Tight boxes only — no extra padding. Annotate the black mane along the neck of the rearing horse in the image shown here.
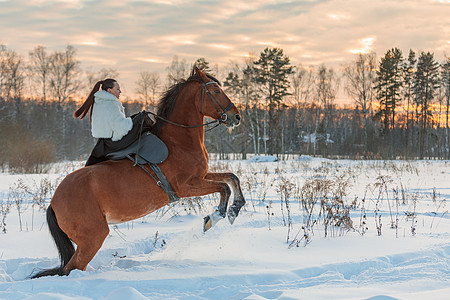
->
[152,66,221,135]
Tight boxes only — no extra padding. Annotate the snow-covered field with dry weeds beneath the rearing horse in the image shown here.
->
[0,156,450,300]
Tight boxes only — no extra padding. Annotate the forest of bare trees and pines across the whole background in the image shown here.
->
[0,44,450,172]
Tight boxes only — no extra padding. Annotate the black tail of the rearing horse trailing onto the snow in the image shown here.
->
[31,205,75,278]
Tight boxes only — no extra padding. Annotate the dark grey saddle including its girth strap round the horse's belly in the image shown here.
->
[106,131,180,203]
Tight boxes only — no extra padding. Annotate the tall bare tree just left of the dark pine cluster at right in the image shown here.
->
[343,53,376,153]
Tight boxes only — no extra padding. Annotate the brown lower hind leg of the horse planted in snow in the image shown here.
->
[60,220,109,274]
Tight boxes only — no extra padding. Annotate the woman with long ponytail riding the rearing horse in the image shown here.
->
[73,78,145,166]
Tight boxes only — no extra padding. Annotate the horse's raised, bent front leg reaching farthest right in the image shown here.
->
[205,173,245,224]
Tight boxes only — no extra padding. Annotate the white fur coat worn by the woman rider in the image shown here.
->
[91,90,133,141]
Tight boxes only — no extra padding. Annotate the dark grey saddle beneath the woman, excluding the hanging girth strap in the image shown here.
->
[106,132,169,164]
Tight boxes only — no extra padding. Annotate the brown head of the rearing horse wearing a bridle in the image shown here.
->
[195,67,241,128]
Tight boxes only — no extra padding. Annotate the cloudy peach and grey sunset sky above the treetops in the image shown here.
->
[0,0,450,101]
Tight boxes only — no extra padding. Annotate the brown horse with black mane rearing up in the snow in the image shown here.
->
[32,68,245,278]
